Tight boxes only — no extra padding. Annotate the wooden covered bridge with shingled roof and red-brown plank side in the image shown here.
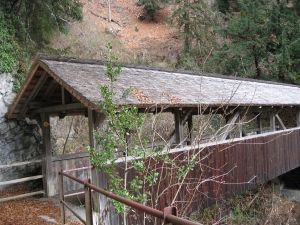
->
[7,56,300,214]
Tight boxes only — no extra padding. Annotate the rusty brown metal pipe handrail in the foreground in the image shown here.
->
[59,170,201,225]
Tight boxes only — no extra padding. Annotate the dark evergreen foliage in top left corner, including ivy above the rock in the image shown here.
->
[0,0,82,71]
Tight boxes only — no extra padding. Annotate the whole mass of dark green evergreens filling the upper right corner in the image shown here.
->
[206,0,300,84]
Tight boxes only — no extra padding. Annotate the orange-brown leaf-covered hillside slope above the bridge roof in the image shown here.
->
[52,0,182,67]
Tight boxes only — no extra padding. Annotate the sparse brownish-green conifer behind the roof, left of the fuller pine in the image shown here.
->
[168,0,216,69]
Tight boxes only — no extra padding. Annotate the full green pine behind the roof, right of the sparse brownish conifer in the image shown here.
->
[209,0,269,78]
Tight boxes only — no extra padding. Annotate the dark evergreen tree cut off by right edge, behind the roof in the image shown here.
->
[268,1,300,84]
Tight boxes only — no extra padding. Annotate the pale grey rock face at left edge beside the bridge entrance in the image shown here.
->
[0,73,42,189]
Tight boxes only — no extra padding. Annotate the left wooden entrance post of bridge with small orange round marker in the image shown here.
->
[41,113,55,197]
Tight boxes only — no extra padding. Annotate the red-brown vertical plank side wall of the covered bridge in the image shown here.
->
[111,129,300,224]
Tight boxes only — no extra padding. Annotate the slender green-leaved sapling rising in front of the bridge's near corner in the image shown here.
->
[89,44,145,223]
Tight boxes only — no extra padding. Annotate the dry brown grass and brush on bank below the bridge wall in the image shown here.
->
[194,183,300,225]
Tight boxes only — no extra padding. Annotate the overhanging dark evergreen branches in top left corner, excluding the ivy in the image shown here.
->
[0,0,82,50]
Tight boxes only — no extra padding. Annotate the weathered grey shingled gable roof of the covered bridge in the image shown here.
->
[7,56,300,119]
